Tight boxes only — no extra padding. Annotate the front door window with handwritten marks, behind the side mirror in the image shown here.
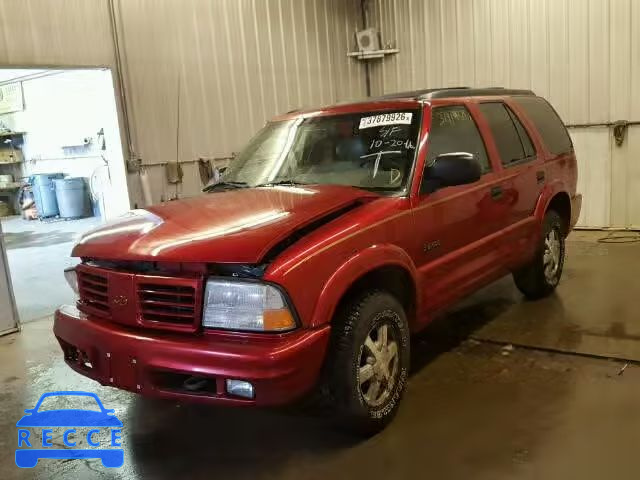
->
[421,105,491,192]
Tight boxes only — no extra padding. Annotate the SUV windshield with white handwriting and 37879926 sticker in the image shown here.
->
[222,110,420,191]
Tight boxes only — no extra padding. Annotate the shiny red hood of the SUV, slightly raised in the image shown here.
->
[72,185,379,263]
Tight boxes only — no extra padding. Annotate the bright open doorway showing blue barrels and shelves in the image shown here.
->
[0,68,129,323]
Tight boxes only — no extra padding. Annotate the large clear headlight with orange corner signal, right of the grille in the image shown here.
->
[202,279,296,332]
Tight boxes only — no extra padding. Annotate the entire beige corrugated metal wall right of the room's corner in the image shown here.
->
[368,0,640,227]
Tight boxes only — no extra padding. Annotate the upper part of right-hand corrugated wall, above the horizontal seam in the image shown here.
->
[370,0,640,124]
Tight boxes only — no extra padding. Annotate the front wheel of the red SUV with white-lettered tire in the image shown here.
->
[327,291,410,435]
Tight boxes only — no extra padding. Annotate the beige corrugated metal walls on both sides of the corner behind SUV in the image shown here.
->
[0,0,640,227]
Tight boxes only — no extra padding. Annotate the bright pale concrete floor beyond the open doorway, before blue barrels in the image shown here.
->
[2,217,100,323]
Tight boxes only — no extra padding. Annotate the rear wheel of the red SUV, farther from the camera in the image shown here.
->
[513,210,566,300]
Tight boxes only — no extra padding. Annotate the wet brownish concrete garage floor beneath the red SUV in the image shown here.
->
[0,233,640,480]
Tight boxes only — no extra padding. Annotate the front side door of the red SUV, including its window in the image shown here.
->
[413,104,508,311]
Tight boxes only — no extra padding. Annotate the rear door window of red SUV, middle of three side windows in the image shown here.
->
[480,102,535,167]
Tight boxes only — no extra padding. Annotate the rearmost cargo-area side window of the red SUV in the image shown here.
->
[513,97,573,155]
